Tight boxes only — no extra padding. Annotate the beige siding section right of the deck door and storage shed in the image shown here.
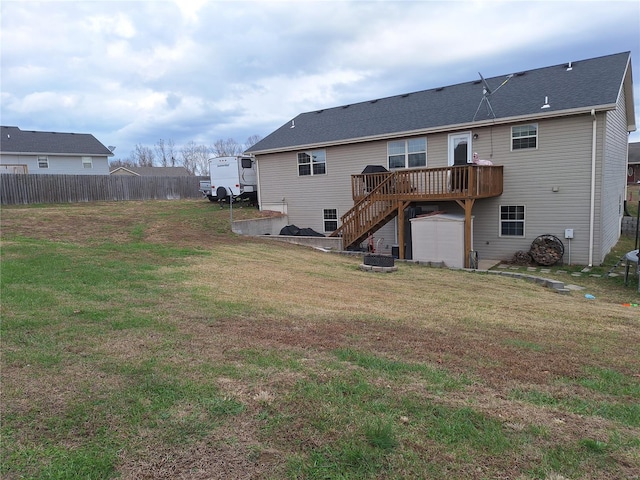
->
[473,115,591,264]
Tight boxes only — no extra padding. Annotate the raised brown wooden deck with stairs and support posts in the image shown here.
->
[331,165,503,261]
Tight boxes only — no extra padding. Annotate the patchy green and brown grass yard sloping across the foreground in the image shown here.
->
[0,201,640,480]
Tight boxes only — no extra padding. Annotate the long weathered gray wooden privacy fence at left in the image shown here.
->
[0,174,206,205]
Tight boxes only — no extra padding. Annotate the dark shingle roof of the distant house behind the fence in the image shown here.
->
[0,126,113,157]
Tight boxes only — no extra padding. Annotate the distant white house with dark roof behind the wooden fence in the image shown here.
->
[0,126,113,175]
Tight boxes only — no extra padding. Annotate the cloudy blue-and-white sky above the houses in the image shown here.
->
[0,0,640,159]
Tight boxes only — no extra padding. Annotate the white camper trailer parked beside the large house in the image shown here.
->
[200,156,258,203]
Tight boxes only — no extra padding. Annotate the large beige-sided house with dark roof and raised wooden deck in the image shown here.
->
[247,52,636,265]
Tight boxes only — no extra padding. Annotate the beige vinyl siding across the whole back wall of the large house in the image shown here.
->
[258,112,625,265]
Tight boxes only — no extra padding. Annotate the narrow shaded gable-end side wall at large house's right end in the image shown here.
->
[594,89,628,263]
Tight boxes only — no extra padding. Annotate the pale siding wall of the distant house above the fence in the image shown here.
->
[0,154,109,175]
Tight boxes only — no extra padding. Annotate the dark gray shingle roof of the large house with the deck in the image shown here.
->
[247,52,635,153]
